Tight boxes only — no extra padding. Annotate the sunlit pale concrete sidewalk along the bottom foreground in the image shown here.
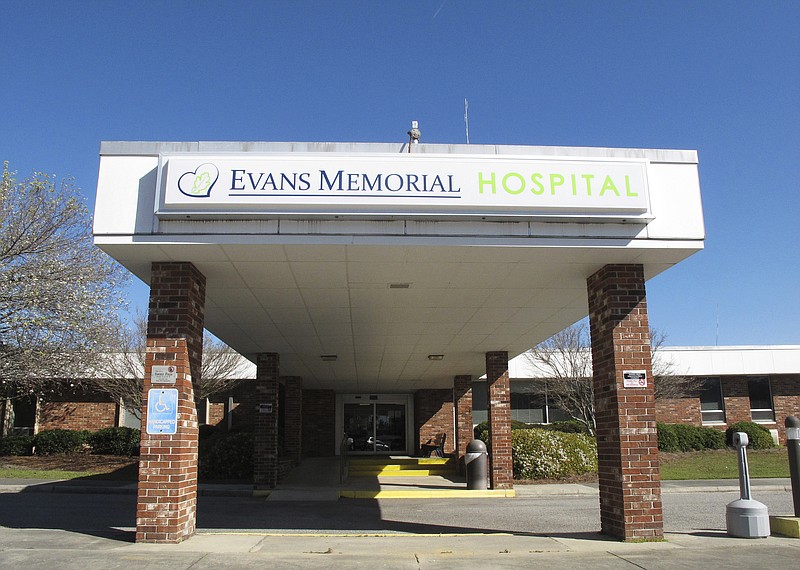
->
[0,528,800,570]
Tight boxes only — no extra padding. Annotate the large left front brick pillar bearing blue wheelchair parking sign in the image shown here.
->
[136,263,205,543]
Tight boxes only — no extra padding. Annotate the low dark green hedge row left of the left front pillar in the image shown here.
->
[0,427,139,456]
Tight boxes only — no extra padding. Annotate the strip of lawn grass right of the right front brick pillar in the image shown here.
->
[661,448,789,480]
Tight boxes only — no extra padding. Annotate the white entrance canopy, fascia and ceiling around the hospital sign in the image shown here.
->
[95,143,703,392]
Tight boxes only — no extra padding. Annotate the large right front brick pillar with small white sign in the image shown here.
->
[587,264,664,540]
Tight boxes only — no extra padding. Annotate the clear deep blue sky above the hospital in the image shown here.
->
[0,0,800,345]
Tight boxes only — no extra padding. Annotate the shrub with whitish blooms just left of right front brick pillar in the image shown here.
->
[511,429,597,479]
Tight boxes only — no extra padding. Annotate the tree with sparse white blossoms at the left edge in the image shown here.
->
[0,162,127,397]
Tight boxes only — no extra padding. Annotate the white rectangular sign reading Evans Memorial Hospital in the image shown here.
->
[157,154,652,220]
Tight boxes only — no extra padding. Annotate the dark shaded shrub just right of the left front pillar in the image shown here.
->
[198,432,253,480]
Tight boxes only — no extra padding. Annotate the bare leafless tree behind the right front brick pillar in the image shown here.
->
[525,320,691,433]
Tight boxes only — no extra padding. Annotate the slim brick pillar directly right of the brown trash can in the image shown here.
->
[486,351,514,489]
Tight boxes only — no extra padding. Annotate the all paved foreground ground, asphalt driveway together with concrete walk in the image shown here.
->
[0,480,800,570]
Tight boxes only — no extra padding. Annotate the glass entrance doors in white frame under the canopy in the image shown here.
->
[337,394,411,455]
